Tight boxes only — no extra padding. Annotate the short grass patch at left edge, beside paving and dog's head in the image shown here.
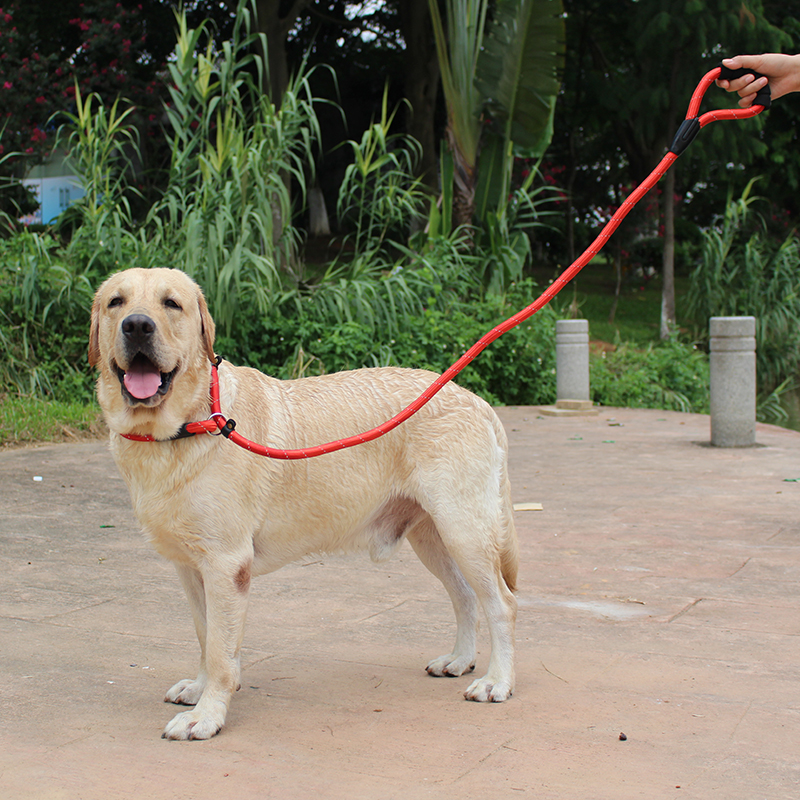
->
[0,396,105,447]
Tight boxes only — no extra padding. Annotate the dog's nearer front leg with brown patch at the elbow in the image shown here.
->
[163,554,252,739]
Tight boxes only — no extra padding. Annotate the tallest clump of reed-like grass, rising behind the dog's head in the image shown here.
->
[146,0,320,333]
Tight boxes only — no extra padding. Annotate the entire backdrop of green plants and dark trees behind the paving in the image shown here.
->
[0,0,800,439]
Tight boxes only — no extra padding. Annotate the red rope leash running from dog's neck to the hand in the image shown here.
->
[126,67,769,459]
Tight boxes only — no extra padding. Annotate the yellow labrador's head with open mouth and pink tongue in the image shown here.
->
[89,269,214,439]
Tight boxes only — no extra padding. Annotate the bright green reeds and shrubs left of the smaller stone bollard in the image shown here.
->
[0,4,568,416]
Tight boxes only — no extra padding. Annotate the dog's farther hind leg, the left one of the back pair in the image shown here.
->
[407,516,478,678]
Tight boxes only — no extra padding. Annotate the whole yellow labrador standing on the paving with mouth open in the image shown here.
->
[89,269,518,739]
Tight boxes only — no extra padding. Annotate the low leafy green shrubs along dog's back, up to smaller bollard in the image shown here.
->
[217,281,555,405]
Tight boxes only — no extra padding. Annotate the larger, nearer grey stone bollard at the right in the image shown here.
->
[709,317,756,447]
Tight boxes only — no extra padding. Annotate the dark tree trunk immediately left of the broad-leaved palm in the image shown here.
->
[399,0,439,192]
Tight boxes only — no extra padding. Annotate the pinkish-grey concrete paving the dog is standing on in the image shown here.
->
[0,408,800,800]
